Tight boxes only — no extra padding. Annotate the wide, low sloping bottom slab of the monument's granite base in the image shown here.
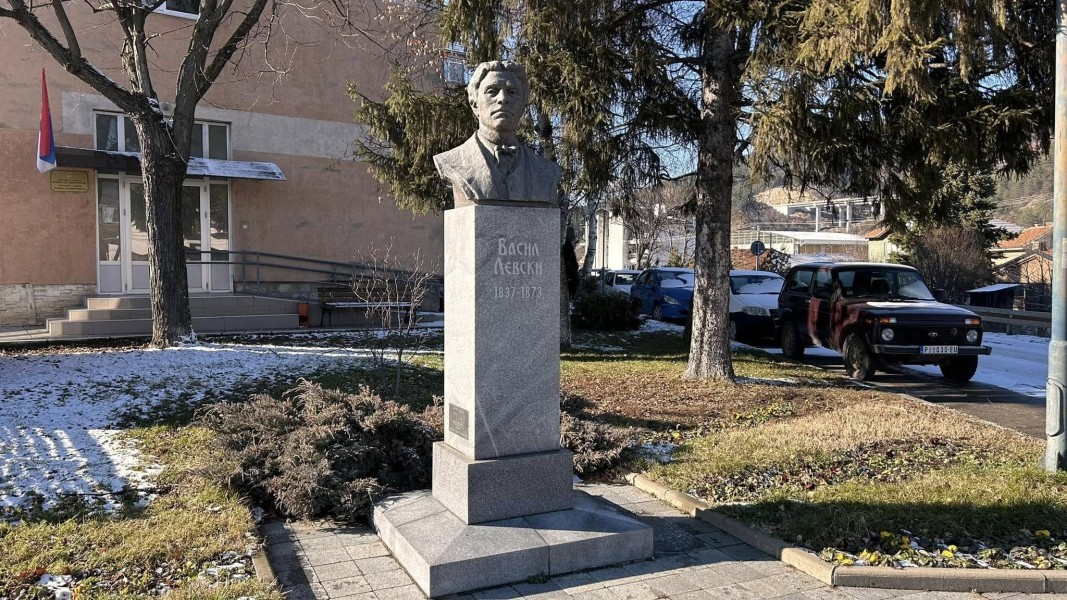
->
[373,490,652,598]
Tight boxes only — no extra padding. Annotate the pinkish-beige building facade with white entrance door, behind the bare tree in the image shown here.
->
[0,3,443,326]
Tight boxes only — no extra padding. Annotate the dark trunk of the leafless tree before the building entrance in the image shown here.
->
[130,112,195,348]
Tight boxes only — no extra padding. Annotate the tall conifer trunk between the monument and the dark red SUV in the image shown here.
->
[685,23,739,380]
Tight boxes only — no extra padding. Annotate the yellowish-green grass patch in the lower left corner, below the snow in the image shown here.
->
[0,427,281,600]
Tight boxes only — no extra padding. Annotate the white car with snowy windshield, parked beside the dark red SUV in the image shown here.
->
[730,270,785,340]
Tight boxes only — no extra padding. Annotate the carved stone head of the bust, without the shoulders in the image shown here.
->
[467,61,529,143]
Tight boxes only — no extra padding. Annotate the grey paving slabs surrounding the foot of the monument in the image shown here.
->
[264,485,1067,600]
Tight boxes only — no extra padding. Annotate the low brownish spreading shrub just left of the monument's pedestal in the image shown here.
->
[203,380,436,520]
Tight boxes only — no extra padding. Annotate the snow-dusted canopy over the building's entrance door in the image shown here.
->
[55,146,285,181]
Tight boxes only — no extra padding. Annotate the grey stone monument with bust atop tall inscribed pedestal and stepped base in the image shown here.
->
[373,61,652,597]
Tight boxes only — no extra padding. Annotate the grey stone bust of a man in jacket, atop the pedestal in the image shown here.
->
[433,61,562,207]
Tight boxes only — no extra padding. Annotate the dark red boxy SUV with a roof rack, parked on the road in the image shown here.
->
[777,263,989,382]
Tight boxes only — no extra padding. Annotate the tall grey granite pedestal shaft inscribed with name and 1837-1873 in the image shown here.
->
[445,205,560,460]
